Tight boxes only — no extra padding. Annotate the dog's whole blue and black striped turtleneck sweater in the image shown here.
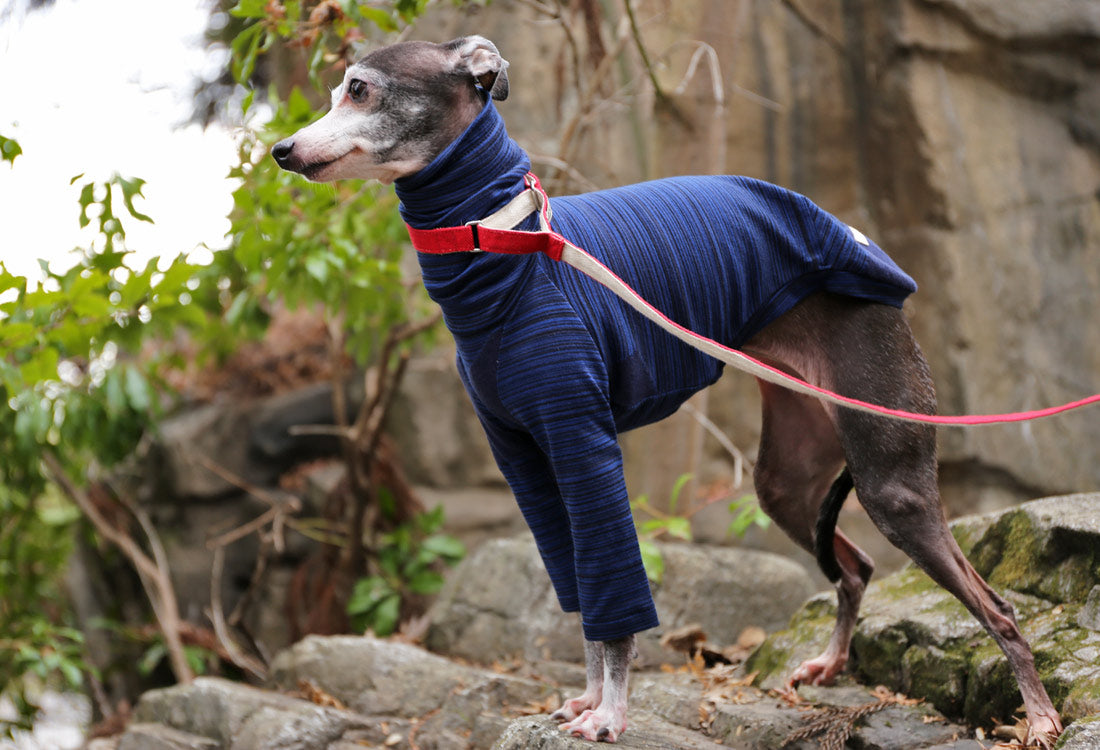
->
[396,97,915,640]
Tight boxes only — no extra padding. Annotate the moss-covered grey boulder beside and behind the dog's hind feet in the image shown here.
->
[749,494,1100,724]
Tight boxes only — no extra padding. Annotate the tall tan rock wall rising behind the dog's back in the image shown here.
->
[400,0,1100,571]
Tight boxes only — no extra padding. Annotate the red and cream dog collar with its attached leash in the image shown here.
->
[408,173,1100,427]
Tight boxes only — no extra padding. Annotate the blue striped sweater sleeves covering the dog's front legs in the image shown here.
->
[483,271,658,640]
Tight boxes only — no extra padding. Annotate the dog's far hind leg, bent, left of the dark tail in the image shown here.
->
[755,383,875,685]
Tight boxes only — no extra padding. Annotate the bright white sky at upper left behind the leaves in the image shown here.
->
[0,0,235,276]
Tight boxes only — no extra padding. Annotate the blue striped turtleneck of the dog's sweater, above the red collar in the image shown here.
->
[394,99,530,229]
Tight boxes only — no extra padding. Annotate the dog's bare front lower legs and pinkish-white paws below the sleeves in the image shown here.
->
[551,636,638,742]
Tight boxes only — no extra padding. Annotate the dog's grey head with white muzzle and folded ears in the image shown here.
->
[272,36,508,183]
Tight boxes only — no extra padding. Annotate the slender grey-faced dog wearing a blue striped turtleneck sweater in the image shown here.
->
[272,36,1062,746]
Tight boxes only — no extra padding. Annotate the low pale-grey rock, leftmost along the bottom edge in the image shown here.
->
[122,677,369,750]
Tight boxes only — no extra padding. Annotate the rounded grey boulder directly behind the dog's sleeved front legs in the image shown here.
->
[426,534,813,665]
